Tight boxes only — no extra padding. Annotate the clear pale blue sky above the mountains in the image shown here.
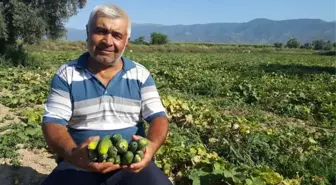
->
[65,0,336,29]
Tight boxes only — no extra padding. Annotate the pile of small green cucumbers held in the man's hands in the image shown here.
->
[88,133,148,165]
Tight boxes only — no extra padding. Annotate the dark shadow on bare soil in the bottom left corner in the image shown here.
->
[0,165,47,185]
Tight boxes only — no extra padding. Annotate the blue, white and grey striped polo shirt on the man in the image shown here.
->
[42,52,166,145]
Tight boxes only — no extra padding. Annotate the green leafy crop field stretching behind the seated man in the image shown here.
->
[0,43,336,185]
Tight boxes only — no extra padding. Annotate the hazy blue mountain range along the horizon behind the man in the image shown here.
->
[67,18,336,44]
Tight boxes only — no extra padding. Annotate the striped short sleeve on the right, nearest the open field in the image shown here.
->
[141,74,167,123]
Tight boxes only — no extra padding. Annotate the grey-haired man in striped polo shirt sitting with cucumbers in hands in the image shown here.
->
[42,5,171,185]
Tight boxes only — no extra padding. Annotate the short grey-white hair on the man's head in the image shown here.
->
[87,4,132,38]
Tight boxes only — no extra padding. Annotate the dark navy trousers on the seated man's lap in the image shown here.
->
[42,161,172,185]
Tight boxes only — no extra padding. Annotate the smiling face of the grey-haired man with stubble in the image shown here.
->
[87,17,128,65]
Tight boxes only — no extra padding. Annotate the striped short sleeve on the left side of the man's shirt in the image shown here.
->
[42,66,72,125]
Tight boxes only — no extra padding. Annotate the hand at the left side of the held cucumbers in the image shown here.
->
[66,136,120,173]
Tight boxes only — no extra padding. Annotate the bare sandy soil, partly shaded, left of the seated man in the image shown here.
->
[0,104,56,185]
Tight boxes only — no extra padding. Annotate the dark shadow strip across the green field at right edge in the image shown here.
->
[259,64,336,75]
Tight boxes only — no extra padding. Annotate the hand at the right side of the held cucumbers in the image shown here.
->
[122,135,157,173]
